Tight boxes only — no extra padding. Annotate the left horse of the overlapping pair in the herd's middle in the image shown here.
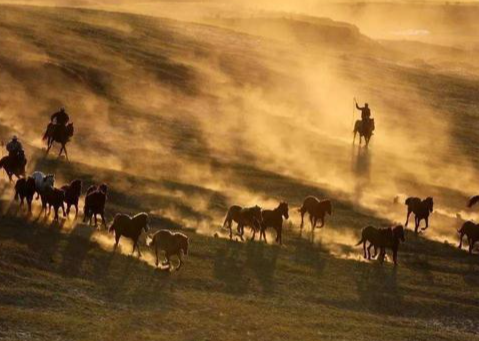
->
[223,205,263,240]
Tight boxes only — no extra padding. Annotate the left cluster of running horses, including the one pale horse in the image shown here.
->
[14,171,189,269]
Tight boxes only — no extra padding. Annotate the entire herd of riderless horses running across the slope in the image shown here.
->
[0,115,479,270]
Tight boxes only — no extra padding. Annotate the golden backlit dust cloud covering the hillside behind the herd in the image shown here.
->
[0,1,479,257]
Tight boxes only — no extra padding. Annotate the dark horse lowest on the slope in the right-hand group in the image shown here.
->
[356,225,405,265]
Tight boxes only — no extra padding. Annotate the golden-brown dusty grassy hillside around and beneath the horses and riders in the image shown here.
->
[0,6,479,340]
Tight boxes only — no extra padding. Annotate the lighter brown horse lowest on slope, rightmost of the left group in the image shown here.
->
[146,230,189,270]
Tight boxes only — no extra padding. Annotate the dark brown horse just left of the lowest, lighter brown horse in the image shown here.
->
[108,213,149,257]
